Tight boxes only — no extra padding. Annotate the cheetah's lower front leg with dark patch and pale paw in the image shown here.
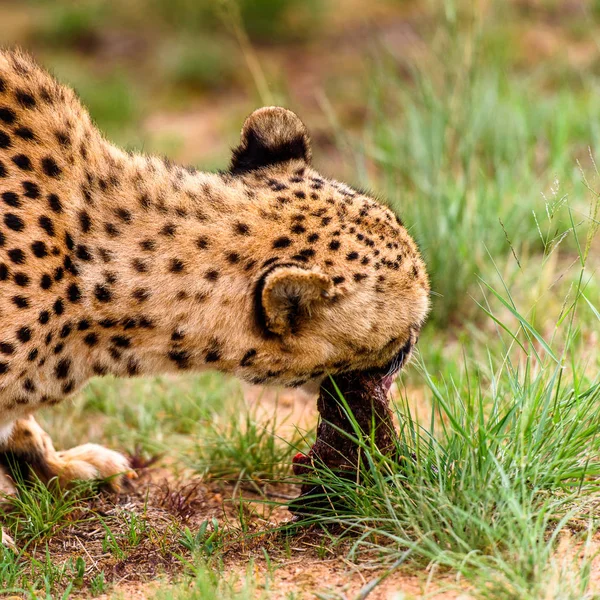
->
[0,415,135,491]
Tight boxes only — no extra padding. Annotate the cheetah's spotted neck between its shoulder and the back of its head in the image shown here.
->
[72,146,253,375]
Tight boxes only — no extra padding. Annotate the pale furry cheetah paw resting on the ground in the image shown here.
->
[57,444,137,491]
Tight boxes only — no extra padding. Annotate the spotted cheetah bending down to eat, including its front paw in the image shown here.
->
[0,51,429,540]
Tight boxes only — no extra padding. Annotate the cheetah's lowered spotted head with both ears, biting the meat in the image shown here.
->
[230,107,429,386]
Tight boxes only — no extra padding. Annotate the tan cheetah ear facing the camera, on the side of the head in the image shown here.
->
[257,266,333,335]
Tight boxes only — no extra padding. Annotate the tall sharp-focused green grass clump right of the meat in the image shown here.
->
[284,182,600,600]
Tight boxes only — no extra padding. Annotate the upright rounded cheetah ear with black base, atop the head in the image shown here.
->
[230,106,311,174]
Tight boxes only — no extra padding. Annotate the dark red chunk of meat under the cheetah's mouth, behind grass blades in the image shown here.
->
[289,371,397,514]
